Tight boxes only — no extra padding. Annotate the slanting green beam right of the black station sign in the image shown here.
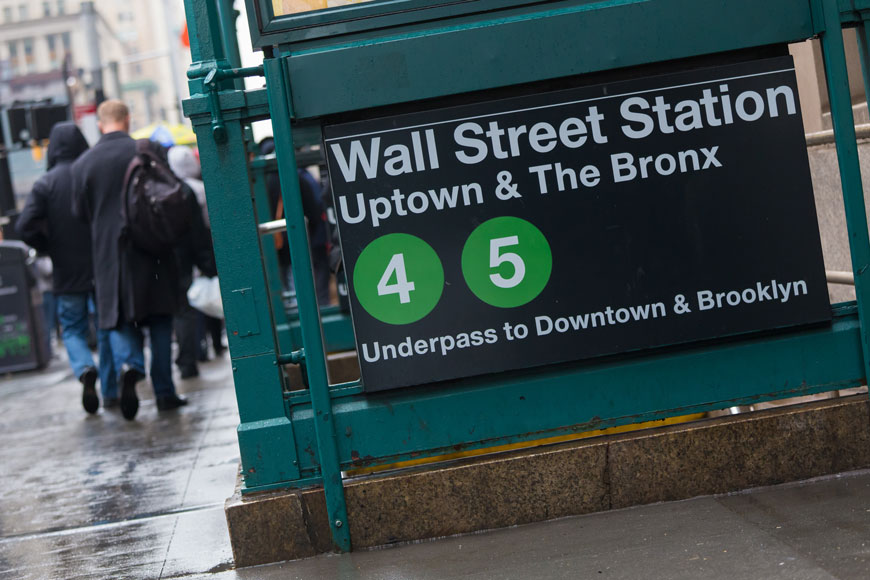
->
[821,0,870,386]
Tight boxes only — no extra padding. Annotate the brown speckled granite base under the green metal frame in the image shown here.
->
[225,394,870,567]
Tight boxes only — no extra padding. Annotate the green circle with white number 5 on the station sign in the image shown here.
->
[462,217,553,308]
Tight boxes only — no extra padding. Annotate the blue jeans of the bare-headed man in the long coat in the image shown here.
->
[109,315,175,397]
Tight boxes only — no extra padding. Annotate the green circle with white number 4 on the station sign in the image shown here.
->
[353,234,444,324]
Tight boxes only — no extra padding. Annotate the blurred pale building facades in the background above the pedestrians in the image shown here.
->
[0,0,190,128]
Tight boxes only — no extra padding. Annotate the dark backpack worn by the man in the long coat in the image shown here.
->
[121,139,192,255]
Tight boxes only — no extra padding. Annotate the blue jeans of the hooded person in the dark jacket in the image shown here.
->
[55,292,118,399]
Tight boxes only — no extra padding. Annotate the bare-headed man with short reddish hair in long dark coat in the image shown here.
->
[72,100,187,419]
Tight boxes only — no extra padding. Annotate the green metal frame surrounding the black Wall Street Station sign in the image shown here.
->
[185,0,870,550]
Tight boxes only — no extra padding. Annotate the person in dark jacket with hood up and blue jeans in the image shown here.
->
[15,122,118,413]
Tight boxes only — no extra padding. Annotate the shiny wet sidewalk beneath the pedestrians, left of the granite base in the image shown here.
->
[0,359,239,580]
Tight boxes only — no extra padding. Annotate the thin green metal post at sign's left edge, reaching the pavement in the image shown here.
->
[264,59,351,552]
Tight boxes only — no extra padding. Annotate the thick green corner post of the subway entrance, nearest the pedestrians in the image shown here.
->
[185,0,299,487]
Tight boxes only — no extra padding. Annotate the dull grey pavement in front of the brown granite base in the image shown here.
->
[203,472,870,580]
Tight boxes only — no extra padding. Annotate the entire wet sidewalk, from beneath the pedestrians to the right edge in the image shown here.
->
[0,358,870,580]
